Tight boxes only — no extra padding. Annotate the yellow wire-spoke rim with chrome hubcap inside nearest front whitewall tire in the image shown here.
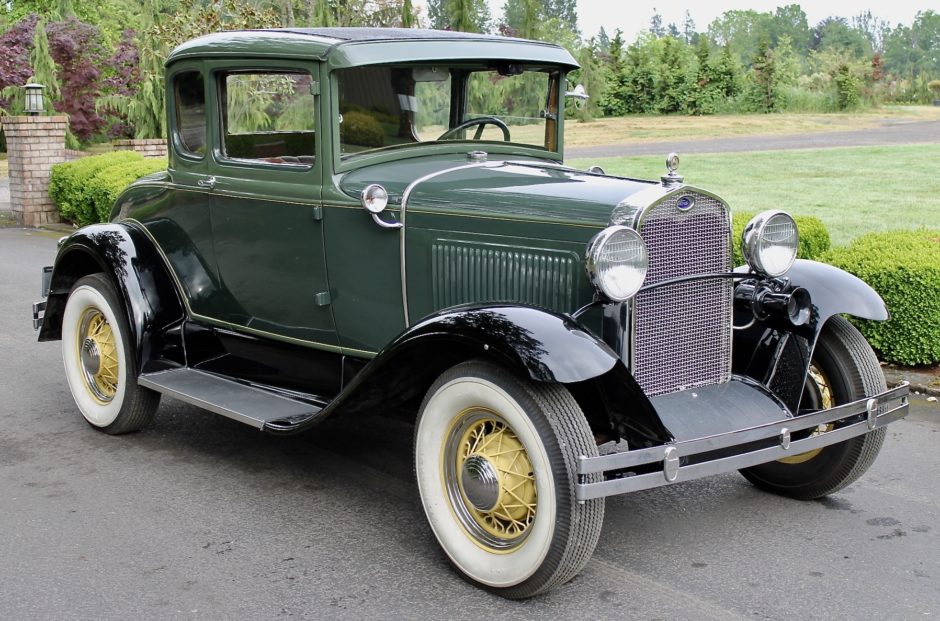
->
[442,408,538,551]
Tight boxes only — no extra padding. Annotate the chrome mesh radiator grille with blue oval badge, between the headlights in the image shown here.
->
[633,194,734,395]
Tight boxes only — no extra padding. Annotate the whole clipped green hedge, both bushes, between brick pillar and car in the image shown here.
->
[49,151,166,226]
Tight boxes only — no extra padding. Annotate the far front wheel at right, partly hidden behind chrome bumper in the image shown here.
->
[741,316,886,500]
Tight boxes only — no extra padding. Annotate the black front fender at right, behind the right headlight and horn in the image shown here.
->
[733,259,888,412]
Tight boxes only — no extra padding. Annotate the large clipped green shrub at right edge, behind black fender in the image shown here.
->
[825,229,940,365]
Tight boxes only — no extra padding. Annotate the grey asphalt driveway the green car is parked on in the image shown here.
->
[0,229,940,621]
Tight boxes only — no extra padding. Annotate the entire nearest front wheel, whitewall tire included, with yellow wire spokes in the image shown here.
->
[415,362,604,598]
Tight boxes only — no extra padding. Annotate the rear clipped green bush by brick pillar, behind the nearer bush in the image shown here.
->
[49,151,144,226]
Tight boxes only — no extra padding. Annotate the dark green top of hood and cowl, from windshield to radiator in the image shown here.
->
[340,156,658,226]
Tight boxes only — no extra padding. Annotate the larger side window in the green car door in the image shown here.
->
[220,72,316,166]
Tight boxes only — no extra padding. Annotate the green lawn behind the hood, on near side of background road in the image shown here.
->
[566,145,940,245]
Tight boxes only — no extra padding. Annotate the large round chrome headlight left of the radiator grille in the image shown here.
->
[586,226,649,302]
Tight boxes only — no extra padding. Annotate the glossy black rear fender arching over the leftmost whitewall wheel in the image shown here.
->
[39,224,185,373]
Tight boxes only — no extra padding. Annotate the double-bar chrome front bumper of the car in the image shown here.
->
[575,382,908,501]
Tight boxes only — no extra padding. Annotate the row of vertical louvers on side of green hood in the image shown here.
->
[431,240,580,312]
